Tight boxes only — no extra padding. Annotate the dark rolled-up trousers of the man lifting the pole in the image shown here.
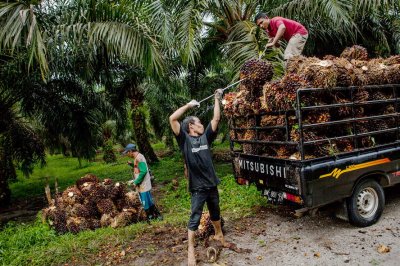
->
[188,187,220,231]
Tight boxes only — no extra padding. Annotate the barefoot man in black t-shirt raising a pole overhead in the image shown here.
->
[169,89,225,266]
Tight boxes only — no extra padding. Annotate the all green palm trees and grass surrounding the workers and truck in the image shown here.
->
[0,0,400,265]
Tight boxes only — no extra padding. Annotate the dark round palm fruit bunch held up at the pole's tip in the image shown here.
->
[240,59,274,91]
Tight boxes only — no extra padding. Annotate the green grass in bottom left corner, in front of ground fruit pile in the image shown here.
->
[0,214,144,266]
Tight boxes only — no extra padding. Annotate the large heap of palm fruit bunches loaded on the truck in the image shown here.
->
[224,45,400,159]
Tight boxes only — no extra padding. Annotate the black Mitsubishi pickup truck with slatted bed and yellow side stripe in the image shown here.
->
[229,84,400,227]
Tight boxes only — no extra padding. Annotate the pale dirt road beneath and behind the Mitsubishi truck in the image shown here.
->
[218,186,400,265]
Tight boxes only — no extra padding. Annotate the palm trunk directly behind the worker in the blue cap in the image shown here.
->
[131,99,158,163]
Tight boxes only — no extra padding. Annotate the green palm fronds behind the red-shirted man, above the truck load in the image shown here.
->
[172,0,400,74]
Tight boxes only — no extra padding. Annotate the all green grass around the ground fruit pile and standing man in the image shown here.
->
[0,144,266,265]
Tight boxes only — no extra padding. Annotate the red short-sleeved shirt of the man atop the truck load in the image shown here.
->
[267,17,308,41]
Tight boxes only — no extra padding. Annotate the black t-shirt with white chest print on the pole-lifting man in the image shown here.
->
[175,123,220,191]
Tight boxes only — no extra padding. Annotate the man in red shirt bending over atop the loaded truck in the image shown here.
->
[254,13,308,62]
